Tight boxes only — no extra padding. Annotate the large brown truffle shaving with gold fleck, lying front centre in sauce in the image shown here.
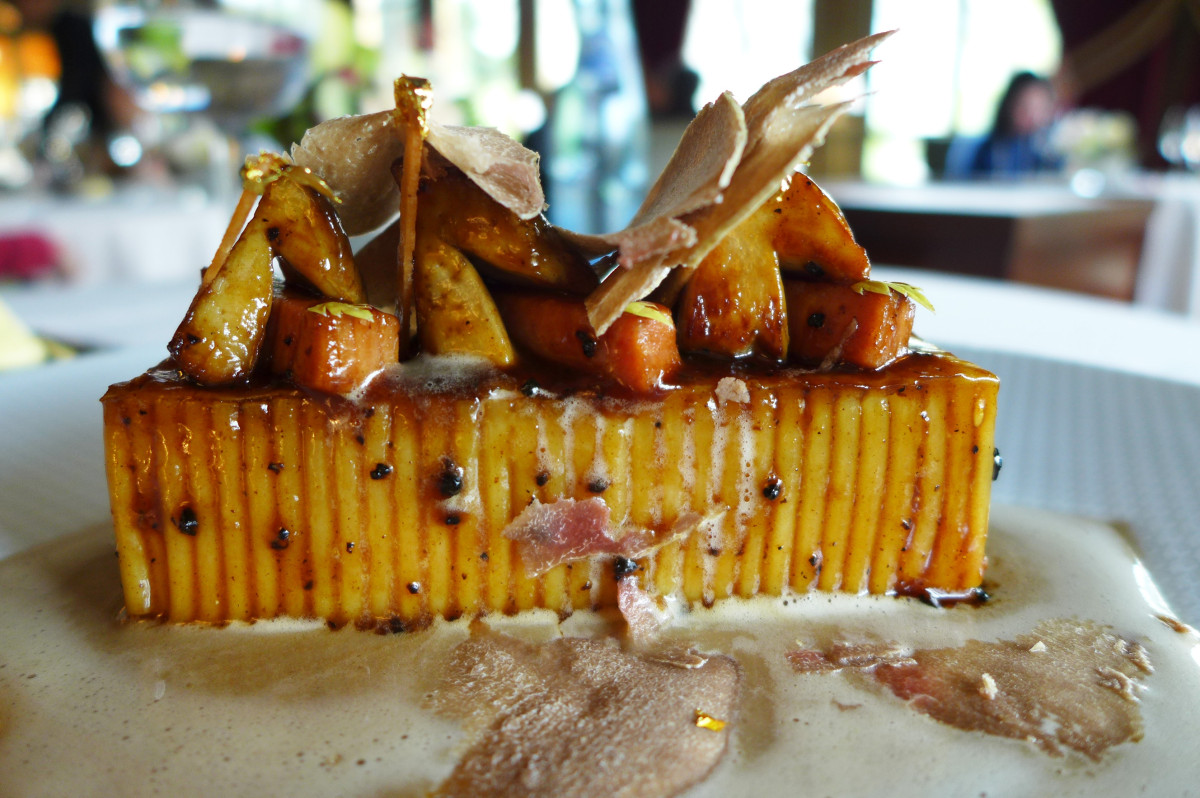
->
[431,632,740,798]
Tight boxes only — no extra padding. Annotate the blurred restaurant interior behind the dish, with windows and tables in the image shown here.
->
[0,0,1200,367]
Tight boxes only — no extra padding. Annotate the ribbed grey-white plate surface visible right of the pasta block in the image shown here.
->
[954,347,1200,625]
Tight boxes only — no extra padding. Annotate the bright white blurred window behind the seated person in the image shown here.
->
[863,0,1062,182]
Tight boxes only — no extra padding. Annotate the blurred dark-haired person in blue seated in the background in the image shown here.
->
[946,72,1062,179]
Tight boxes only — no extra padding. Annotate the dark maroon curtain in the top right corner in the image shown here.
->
[1052,0,1200,168]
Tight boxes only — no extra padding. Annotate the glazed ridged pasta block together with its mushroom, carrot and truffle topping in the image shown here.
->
[102,34,997,630]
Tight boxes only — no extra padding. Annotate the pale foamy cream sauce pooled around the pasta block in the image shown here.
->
[0,508,1200,797]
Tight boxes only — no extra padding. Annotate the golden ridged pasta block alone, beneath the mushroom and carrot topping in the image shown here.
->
[103,353,998,628]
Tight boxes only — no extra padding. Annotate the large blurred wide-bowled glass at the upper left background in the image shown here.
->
[95,0,319,192]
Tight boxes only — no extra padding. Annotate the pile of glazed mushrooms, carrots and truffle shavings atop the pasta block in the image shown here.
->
[170,30,913,394]
